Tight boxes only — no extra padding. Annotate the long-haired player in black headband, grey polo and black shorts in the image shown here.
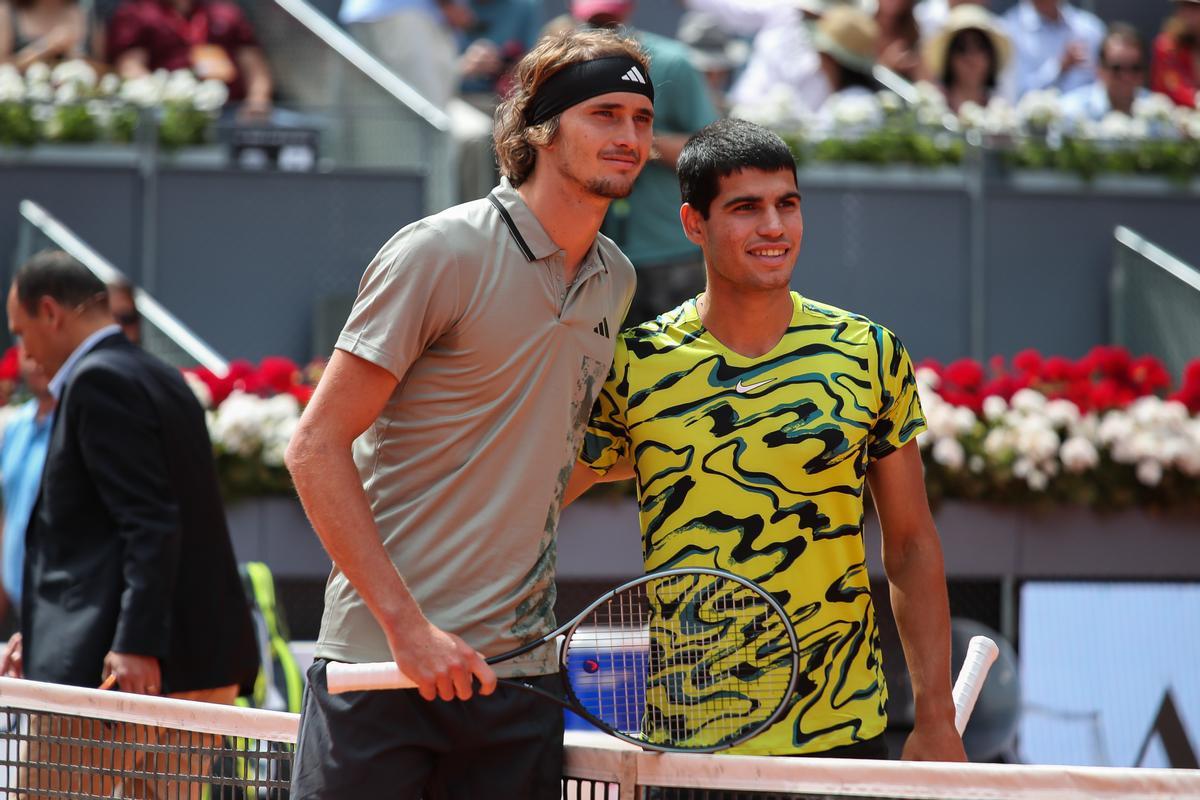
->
[287,31,654,800]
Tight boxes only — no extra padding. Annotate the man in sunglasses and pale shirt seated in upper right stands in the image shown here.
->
[1062,23,1150,122]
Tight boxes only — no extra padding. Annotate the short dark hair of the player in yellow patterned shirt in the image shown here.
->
[676,119,796,219]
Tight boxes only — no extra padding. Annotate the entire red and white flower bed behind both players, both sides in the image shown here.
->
[175,347,1200,510]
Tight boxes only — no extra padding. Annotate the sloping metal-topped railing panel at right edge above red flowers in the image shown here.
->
[1110,225,1200,375]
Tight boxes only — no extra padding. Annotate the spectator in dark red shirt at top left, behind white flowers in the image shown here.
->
[108,0,274,121]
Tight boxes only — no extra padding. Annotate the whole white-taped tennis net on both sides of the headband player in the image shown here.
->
[0,678,1200,800]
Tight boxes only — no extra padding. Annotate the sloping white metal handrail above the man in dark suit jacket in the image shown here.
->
[16,200,229,375]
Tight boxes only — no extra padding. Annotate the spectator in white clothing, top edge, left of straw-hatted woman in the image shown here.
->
[688,0,852,120]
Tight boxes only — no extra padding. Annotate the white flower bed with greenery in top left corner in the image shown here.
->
[0,61,229,149]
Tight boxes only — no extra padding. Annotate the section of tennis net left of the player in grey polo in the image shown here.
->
[0,678,298,800]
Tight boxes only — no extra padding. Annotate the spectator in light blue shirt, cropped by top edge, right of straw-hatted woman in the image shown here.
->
[1003,0,1104,100]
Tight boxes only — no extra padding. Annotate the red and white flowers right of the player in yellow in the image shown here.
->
[917,347,1200,509]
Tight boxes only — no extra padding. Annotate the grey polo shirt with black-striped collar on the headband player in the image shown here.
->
[317,181,634,676]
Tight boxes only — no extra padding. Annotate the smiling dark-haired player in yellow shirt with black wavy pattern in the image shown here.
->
[568,120,966,760]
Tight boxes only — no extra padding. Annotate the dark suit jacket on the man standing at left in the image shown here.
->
[22,333,258,693]
